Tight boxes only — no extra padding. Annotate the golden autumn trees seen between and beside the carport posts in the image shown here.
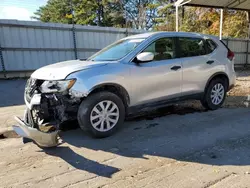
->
[181,8,248,38]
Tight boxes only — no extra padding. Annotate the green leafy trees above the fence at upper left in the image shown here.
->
[34,0,125,26]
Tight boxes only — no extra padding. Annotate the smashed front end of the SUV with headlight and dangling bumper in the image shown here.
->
[13,78,81,147]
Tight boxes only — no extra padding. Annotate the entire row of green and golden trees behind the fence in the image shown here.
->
[35,0,248,38]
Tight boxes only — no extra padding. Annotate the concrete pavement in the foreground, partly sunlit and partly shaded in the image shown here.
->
[0,108,250,188]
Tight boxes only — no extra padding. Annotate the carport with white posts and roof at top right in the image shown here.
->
[175,0,250,39]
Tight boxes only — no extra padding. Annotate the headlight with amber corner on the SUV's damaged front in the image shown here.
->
[40,79,76,93]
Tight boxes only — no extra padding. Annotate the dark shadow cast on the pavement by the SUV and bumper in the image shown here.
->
[38,106,250,177]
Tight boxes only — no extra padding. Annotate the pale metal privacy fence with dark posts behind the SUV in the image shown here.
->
[0,20,250,75]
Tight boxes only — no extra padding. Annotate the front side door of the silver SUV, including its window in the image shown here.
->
[131,37,182,105]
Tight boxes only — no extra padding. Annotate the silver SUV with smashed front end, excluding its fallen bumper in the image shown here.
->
[13,32,235,141]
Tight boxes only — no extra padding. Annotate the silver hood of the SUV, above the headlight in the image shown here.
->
[31,60,109,80]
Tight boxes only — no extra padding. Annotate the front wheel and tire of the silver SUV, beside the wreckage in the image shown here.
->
[77,91,125,138]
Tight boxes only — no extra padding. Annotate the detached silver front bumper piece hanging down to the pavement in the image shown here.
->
[13,117,59,147]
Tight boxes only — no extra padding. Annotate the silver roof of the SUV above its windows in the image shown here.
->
[124,31,215,39]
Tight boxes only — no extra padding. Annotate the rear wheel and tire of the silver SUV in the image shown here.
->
[201,78,227,110]
